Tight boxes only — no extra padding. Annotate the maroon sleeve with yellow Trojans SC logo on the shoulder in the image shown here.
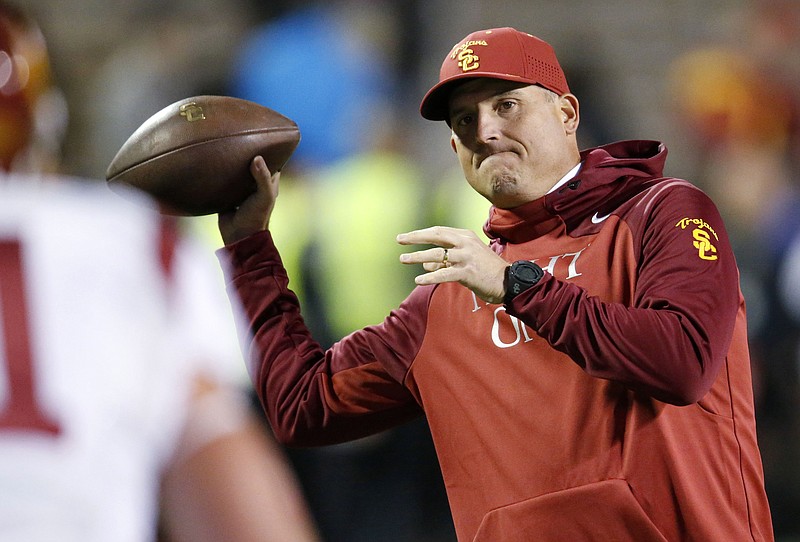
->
[508,184,740,405]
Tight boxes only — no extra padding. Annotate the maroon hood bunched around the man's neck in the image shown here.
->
[484,141,667,243]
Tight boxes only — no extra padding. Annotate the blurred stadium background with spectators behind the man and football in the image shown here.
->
[11,0,800,542]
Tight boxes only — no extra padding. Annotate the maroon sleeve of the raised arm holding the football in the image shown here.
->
[218,232,421,446]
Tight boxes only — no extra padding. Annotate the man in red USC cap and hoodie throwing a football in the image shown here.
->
[219,28,773,542]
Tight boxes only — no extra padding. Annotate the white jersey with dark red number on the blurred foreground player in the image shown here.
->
[0,177,243,542]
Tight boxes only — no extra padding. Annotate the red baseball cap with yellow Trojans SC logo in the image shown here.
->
[419,27,569,120]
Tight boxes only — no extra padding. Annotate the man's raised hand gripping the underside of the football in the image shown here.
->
[218,156,281,246]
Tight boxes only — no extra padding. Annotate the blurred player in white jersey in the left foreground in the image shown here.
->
[0,3,318,542]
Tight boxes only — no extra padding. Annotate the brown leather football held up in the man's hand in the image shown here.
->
[106,96,300,216]
